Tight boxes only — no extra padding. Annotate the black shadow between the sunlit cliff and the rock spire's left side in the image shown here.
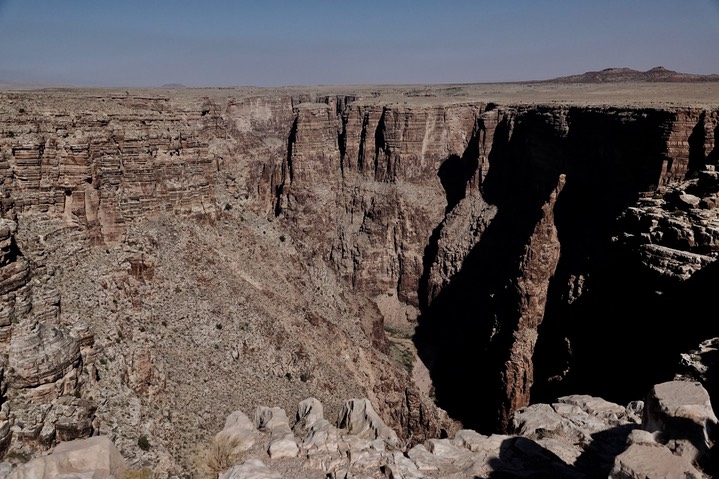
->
[415,110,572,432]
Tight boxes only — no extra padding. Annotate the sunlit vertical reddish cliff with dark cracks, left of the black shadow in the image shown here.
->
[275,104,483,319]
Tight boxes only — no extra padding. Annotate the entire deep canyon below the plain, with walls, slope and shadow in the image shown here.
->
[0,82,719,477]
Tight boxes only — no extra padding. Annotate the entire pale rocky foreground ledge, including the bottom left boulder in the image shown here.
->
[0,381,717,479]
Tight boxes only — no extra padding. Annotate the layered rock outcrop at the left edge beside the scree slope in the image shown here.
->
[0,171,97,460]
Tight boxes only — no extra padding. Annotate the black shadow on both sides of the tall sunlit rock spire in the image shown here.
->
[414,108,717,433]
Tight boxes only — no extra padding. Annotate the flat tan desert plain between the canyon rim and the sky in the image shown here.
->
[5,81,719,108]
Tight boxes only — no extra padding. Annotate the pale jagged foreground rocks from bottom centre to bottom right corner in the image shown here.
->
[204,381,714,479]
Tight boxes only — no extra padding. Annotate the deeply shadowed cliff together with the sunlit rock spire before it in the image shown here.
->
[416,107,717,431]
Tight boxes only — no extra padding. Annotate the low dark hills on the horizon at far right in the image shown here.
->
[547,66,719,83]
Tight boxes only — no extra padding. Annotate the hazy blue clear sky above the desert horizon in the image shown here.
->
[0,0,719,87]
